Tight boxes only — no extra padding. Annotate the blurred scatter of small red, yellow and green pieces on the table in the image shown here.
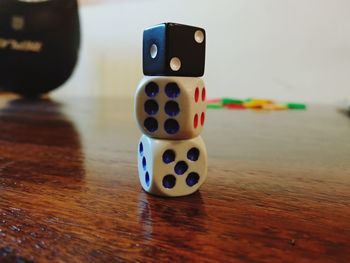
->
[207,98,306,110]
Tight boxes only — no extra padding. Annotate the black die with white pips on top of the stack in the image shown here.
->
[143,23,206,77]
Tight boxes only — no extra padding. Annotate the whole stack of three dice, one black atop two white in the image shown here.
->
[135,23,208,197]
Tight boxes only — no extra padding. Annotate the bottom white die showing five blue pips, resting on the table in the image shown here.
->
[138,135,208,196]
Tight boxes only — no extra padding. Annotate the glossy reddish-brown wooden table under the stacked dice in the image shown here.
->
[0,96,350,262]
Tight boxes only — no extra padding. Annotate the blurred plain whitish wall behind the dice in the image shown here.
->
[56,0,350,103]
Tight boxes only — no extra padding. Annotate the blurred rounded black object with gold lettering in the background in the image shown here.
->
[0,0,80,96]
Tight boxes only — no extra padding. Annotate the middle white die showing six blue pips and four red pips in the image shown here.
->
[135,77,206,140]
